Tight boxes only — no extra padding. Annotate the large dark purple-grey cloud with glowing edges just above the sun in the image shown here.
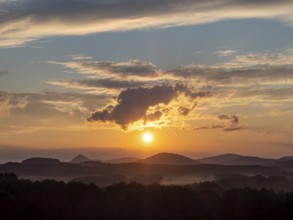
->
[88,84,211,130]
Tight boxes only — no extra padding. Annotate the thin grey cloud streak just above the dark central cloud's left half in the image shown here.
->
[47,79,145,89]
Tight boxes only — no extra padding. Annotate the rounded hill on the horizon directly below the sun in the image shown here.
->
[138,153,199,165]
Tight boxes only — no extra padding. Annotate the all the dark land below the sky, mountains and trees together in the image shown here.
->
[0,153,293,220]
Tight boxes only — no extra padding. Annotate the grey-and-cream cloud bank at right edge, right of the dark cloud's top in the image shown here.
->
[165,50,293,86]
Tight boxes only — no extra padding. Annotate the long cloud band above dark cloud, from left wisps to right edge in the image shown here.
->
[51,50,293,87]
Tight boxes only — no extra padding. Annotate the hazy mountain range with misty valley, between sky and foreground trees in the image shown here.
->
[0,153,293,186]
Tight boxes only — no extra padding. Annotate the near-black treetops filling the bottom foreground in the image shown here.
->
[0,174,293,220]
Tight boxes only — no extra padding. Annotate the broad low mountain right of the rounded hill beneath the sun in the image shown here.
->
[198,154,275,165]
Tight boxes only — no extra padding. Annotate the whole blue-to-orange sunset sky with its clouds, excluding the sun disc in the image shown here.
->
[0,0,293,161]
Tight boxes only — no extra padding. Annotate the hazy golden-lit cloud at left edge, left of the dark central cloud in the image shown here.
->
[0,92,109,121]
